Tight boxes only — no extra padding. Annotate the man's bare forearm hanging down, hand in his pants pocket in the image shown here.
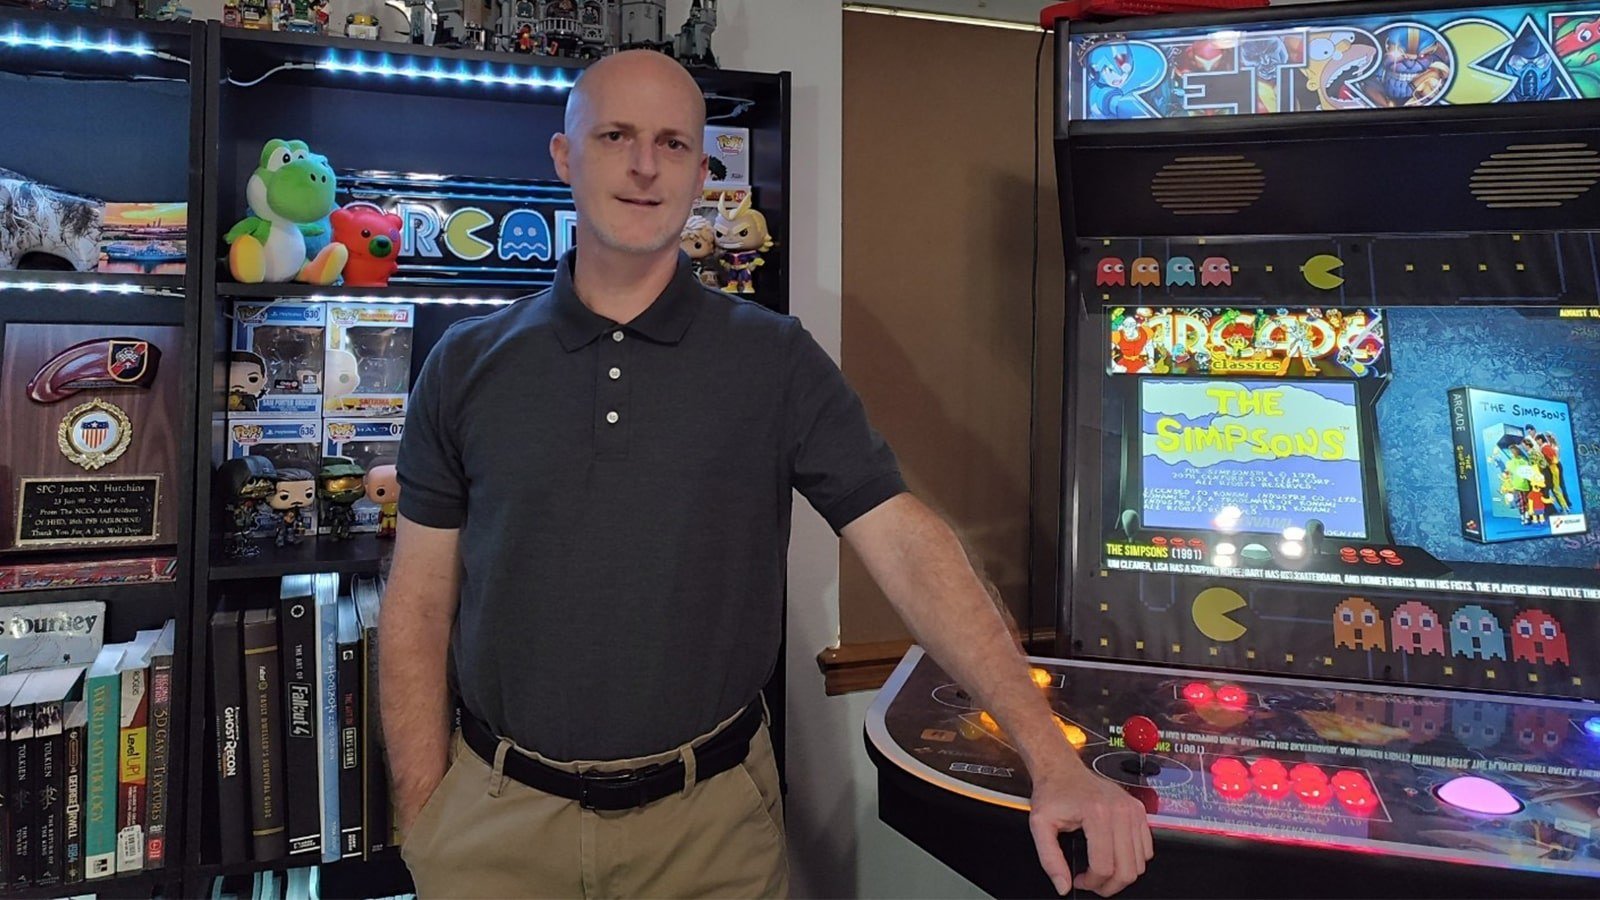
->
[378,583,450,828]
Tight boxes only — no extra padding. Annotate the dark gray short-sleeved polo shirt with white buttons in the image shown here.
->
[398,253,906,759]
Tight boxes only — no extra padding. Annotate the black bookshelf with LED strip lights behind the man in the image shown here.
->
[0,8,792,897]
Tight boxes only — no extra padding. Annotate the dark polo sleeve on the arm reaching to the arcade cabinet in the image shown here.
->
[784,320,906,533]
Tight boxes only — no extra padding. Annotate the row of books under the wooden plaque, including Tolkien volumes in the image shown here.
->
[0,620,174,889]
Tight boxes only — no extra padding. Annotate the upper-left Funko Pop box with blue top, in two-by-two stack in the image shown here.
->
[227,299,328,418]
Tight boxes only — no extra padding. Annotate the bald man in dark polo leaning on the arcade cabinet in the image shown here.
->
[381,51,1150,897]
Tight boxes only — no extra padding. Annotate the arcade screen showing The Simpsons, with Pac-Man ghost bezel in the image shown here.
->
[1069,235,1600,697]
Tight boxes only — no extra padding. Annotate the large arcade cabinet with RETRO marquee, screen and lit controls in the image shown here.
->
[867,3,1600,897]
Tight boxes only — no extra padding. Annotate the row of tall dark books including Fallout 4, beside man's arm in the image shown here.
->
[210,573,394,865]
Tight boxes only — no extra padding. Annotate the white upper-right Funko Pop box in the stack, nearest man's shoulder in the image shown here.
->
[322,303,416,416]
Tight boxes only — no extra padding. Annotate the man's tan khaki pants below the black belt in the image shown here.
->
[400,704,789,900]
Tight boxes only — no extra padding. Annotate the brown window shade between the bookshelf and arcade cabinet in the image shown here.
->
[840,13,1064,644]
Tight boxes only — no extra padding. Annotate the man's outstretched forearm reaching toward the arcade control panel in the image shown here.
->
[867,495,1083,780]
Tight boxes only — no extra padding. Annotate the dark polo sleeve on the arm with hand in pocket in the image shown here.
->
[395,333,467,528]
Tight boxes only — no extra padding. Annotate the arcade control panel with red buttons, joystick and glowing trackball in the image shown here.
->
[867,647,1600,895]
